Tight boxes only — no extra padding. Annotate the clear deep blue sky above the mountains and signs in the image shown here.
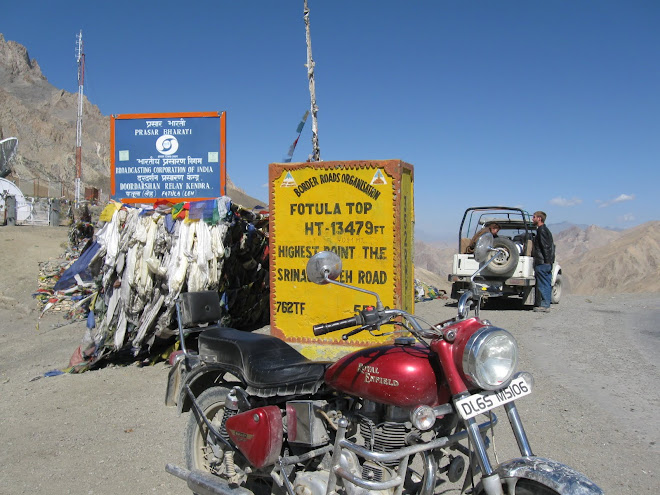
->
[0,0,660,240]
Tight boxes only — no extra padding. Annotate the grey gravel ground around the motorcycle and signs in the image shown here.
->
[0,227,660,495]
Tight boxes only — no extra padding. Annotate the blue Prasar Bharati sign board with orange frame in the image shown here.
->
[111,112,225,202]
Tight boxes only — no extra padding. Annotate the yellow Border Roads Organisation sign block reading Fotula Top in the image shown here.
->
[269,160,414,346]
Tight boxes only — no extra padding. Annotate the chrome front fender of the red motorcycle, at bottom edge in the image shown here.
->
[495,457,603,495]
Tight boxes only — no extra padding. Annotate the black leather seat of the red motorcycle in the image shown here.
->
[199,326,330,395]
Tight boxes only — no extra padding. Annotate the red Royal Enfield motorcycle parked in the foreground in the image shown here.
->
[166,236,603,495]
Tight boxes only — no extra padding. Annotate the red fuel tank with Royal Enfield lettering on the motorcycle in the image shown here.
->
[325,345,451,408]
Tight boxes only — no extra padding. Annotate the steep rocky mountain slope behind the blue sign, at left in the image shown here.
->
[0,33,267,208]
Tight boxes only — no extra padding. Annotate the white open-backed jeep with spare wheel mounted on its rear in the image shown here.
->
[448,206,562,305]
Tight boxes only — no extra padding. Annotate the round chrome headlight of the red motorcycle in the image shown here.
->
[463,326,518,390]
